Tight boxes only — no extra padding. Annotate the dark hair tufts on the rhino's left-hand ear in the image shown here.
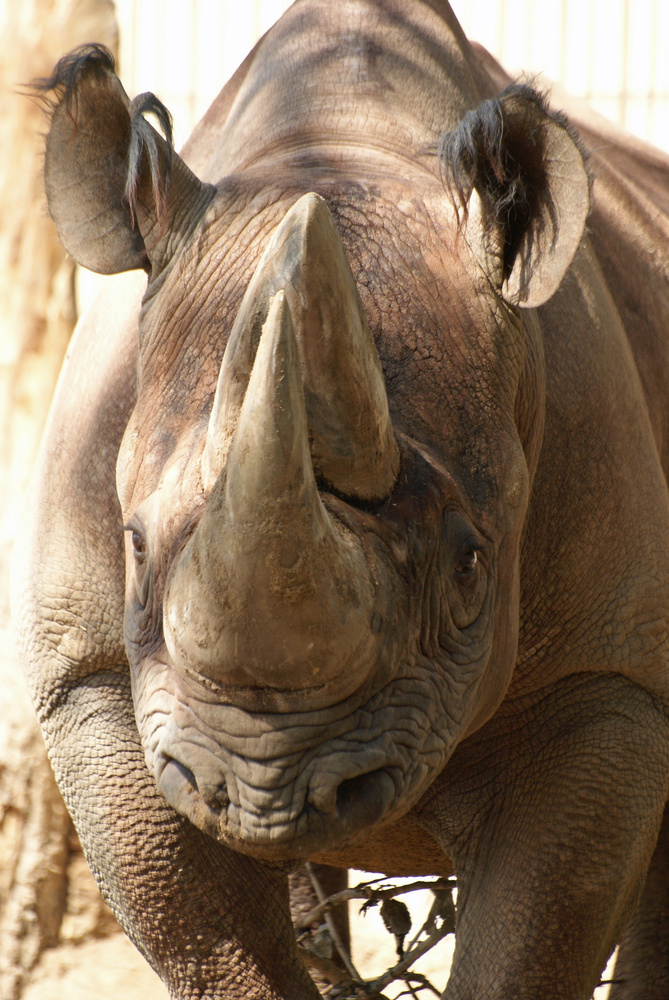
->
[26,42,174,238]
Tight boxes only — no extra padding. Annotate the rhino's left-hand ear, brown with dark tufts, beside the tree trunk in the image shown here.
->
[34,45,213,274]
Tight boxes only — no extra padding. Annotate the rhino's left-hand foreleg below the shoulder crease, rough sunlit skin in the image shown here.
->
[45,672,319,1000]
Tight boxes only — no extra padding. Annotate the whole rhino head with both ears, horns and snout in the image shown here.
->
[39,27,588,860]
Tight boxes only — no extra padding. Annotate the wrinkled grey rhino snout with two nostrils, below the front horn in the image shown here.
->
[134,658,459,861]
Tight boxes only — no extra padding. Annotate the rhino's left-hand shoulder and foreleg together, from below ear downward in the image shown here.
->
[14,274,318,1000]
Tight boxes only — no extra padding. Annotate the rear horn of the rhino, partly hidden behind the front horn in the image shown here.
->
[202,193,399,501]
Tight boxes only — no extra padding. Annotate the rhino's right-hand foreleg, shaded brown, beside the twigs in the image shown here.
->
[414,675,669,1000]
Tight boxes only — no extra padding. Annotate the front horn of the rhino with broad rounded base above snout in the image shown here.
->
[164,292,385,703]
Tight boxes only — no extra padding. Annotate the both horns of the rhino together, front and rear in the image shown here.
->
[163,194,399,705]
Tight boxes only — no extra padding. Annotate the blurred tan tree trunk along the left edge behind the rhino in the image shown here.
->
[0,0,118,1000]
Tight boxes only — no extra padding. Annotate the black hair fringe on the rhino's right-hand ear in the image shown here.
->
[438,84,581,278]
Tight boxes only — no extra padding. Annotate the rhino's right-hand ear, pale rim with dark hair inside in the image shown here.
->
[439,85,590,308]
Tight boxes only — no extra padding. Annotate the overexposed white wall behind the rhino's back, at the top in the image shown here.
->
[112,0,669,150]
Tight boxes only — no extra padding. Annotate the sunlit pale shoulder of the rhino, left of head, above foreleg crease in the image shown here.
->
[12,272,146,711]
